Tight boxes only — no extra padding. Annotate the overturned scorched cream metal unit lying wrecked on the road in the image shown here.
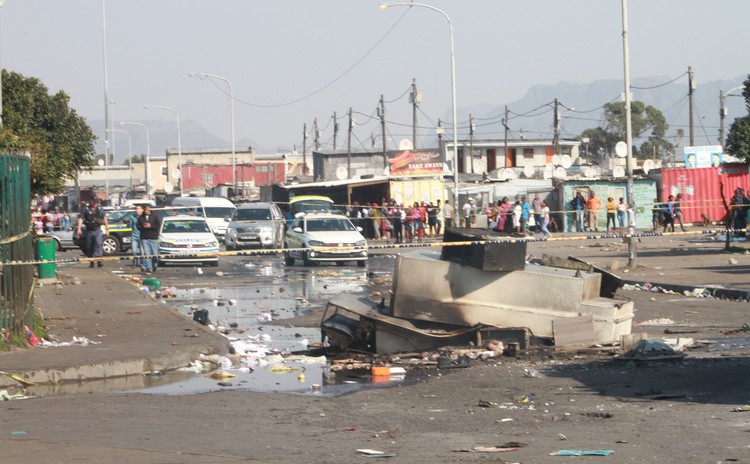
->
[321,229,633,354]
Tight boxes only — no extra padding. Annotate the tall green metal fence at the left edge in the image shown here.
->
[0,154,34,338]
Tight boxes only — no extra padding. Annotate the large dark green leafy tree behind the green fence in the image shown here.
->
[0,70,96,194]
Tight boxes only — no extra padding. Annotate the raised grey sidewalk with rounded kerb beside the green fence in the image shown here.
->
[0,265,229,388]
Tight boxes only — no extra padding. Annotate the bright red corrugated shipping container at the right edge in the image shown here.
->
[661,164,750,222]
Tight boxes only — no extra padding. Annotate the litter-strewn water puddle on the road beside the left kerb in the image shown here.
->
[130,262,415,396]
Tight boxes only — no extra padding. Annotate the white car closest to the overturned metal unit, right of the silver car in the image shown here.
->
[284,213,367,267]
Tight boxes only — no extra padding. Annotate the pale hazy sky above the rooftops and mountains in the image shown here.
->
[0,0,750,160]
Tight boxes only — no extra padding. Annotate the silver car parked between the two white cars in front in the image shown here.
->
[224,203,284,250]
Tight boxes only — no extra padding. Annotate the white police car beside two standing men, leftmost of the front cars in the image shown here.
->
[159,216,219,266]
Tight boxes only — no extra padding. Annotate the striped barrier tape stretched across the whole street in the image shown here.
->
[0,229,750,268]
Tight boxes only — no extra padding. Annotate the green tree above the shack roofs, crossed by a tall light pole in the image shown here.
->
[581,101,674,158]
